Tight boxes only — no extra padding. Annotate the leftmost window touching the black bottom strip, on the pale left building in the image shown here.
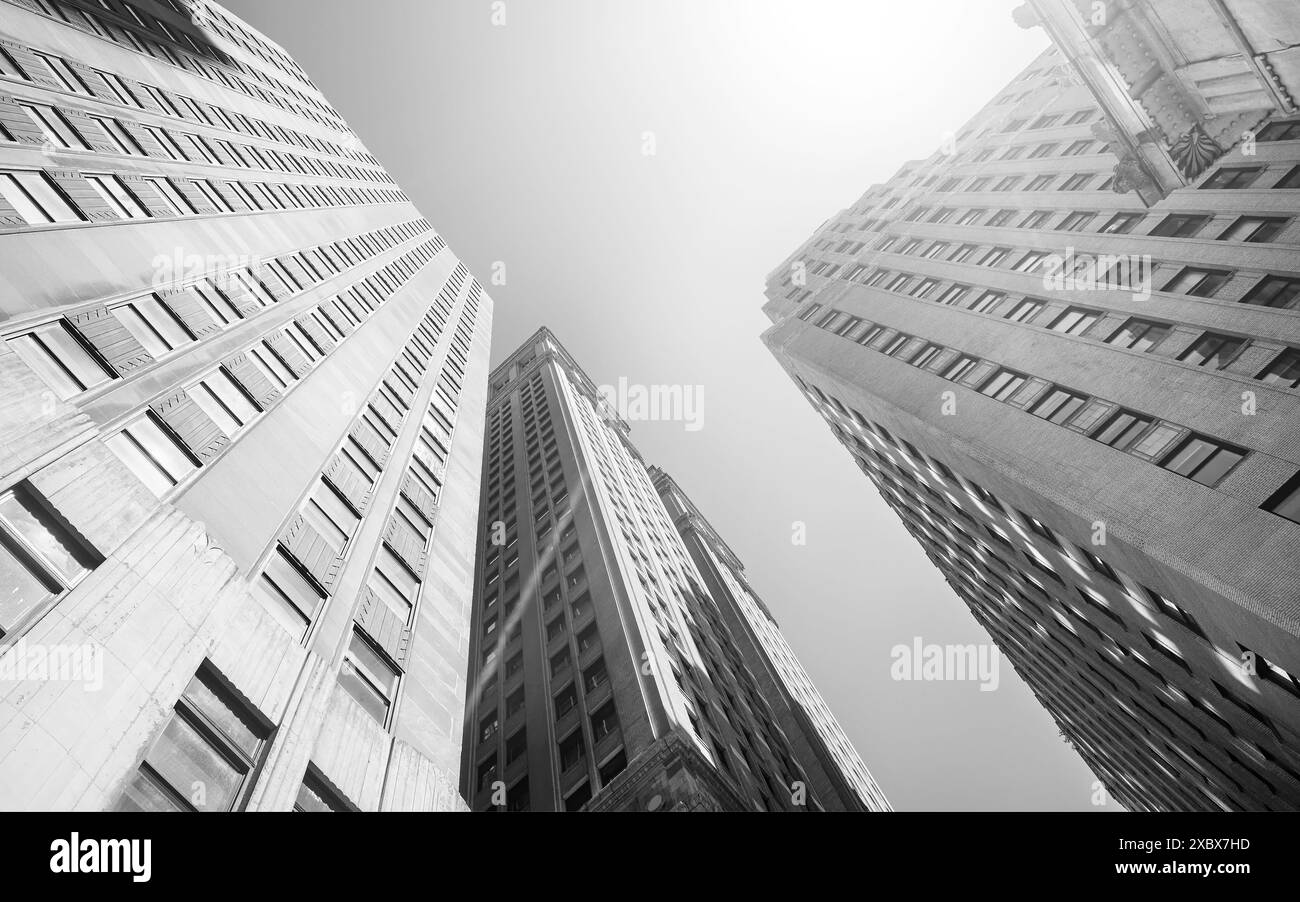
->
[113,665,270,811]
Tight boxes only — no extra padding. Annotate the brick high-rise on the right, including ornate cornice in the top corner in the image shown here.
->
[763,0,1300,810]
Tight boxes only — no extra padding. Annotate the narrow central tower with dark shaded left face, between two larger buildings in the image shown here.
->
[462,329,888,811]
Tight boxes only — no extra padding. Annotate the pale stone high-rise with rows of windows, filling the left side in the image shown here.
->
[0,0,491,811]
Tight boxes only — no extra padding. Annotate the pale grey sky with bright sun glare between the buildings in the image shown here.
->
[226,0,1115,811]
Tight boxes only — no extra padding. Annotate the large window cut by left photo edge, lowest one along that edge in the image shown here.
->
[0,483,99,638]
